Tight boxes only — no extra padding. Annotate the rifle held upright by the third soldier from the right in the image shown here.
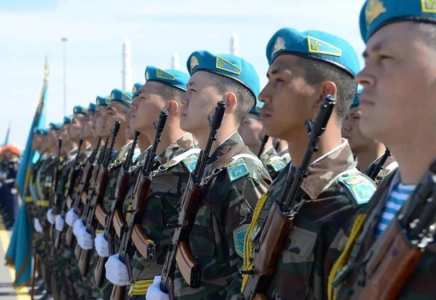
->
[160,100,226,299]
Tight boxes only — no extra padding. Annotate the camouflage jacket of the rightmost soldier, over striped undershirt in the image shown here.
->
[335,170,436,300]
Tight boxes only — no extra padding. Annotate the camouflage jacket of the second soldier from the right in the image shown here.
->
[237,141,375,300]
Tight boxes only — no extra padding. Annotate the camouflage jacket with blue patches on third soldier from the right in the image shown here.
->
[174,132,271,300]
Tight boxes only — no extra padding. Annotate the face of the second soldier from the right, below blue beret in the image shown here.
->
[259,54,318,140]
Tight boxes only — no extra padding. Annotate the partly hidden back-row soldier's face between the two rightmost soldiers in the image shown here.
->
[342,107,375,153]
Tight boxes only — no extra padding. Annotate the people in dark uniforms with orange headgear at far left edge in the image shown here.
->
[0,145,20,229]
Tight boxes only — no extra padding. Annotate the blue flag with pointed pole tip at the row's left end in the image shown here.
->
[6,59,49,287]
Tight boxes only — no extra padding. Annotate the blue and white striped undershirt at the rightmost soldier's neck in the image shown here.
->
[375,183,416,238]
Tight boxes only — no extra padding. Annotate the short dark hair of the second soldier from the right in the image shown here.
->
[298,57,357,122]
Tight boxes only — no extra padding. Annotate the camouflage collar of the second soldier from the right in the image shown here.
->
[301,140,356,199]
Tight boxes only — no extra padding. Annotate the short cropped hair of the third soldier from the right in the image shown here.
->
[208,73,256,123]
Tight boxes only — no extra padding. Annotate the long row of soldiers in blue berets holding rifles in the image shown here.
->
[24,0,436,300]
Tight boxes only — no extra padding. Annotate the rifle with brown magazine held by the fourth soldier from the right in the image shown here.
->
[110,109,168,300]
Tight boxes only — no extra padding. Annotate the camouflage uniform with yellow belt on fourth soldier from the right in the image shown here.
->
[126,133,200,300]
